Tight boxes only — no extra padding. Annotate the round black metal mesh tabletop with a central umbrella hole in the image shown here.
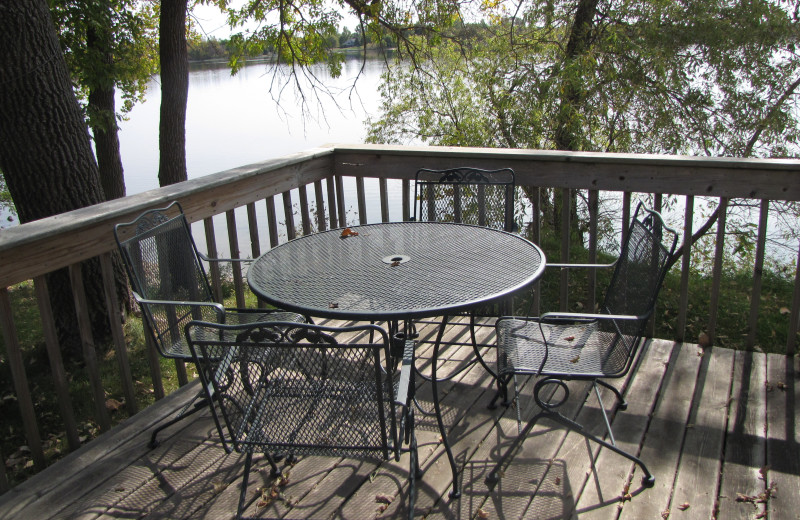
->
[247,222,545,320]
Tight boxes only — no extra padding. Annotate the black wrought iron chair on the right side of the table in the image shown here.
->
[488,204,678,486]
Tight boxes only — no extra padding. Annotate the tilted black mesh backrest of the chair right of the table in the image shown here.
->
[601,203,678,346]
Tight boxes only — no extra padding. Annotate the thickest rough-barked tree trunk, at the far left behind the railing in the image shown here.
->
[0,0,110,358]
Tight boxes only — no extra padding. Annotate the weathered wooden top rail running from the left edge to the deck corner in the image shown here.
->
[0,147,333,287]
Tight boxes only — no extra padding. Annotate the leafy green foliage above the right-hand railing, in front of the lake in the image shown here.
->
[370,0,800,157]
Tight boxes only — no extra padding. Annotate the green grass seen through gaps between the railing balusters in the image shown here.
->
[0,242,793,485]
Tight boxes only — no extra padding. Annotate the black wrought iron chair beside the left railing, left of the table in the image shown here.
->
[114,202,306,448]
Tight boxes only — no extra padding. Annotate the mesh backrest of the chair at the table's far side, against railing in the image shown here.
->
[414,168,516,231]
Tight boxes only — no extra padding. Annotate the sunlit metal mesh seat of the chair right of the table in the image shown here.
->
[497,319,633,378]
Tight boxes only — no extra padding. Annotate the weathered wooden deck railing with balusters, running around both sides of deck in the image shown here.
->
[0,145,800,491]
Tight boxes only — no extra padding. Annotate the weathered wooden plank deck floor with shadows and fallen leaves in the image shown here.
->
[0,316,800,520]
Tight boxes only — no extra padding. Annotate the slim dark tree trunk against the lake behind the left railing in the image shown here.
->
[158,0,189,186]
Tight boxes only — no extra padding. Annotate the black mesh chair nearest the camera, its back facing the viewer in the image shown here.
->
[186,322,420,518]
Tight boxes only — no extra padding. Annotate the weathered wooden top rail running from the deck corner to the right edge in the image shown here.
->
[334,144,800,200]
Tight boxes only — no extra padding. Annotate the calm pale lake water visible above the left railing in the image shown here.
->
[120,57,385,195]
